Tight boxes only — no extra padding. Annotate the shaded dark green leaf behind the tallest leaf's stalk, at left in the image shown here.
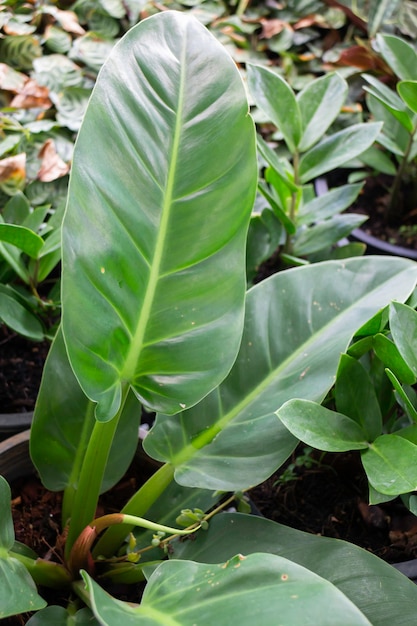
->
[30,330,141,491]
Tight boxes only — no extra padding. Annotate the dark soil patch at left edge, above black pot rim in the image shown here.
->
[0,325,50,413]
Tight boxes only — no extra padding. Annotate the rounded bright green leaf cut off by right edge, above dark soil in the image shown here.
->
[362,435,417,496]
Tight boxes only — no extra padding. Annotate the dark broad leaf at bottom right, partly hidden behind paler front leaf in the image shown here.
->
[173,513,417,626]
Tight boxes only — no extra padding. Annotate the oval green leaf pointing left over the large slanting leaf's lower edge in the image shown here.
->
[276,400,368,452]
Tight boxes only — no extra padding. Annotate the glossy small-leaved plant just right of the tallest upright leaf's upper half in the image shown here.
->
[248,66,381,276]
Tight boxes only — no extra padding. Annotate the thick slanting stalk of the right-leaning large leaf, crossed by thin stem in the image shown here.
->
[93,463,175,558]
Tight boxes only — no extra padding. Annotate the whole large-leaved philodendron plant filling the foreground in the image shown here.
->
[0,12,417,626]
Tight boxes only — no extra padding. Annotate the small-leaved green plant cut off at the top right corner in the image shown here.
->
[363,35,417,226]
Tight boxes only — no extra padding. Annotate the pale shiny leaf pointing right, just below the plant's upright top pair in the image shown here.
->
[300,122,382,184]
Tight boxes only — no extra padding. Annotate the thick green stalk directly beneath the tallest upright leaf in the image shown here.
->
[65,384,129,558]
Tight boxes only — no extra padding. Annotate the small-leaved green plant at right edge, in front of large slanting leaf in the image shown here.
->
[278,302,417,510]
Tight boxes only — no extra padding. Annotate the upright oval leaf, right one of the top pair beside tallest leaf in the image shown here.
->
[297,73,348,152]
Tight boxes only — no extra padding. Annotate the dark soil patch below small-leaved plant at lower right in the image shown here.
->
[250,448,417,563]
